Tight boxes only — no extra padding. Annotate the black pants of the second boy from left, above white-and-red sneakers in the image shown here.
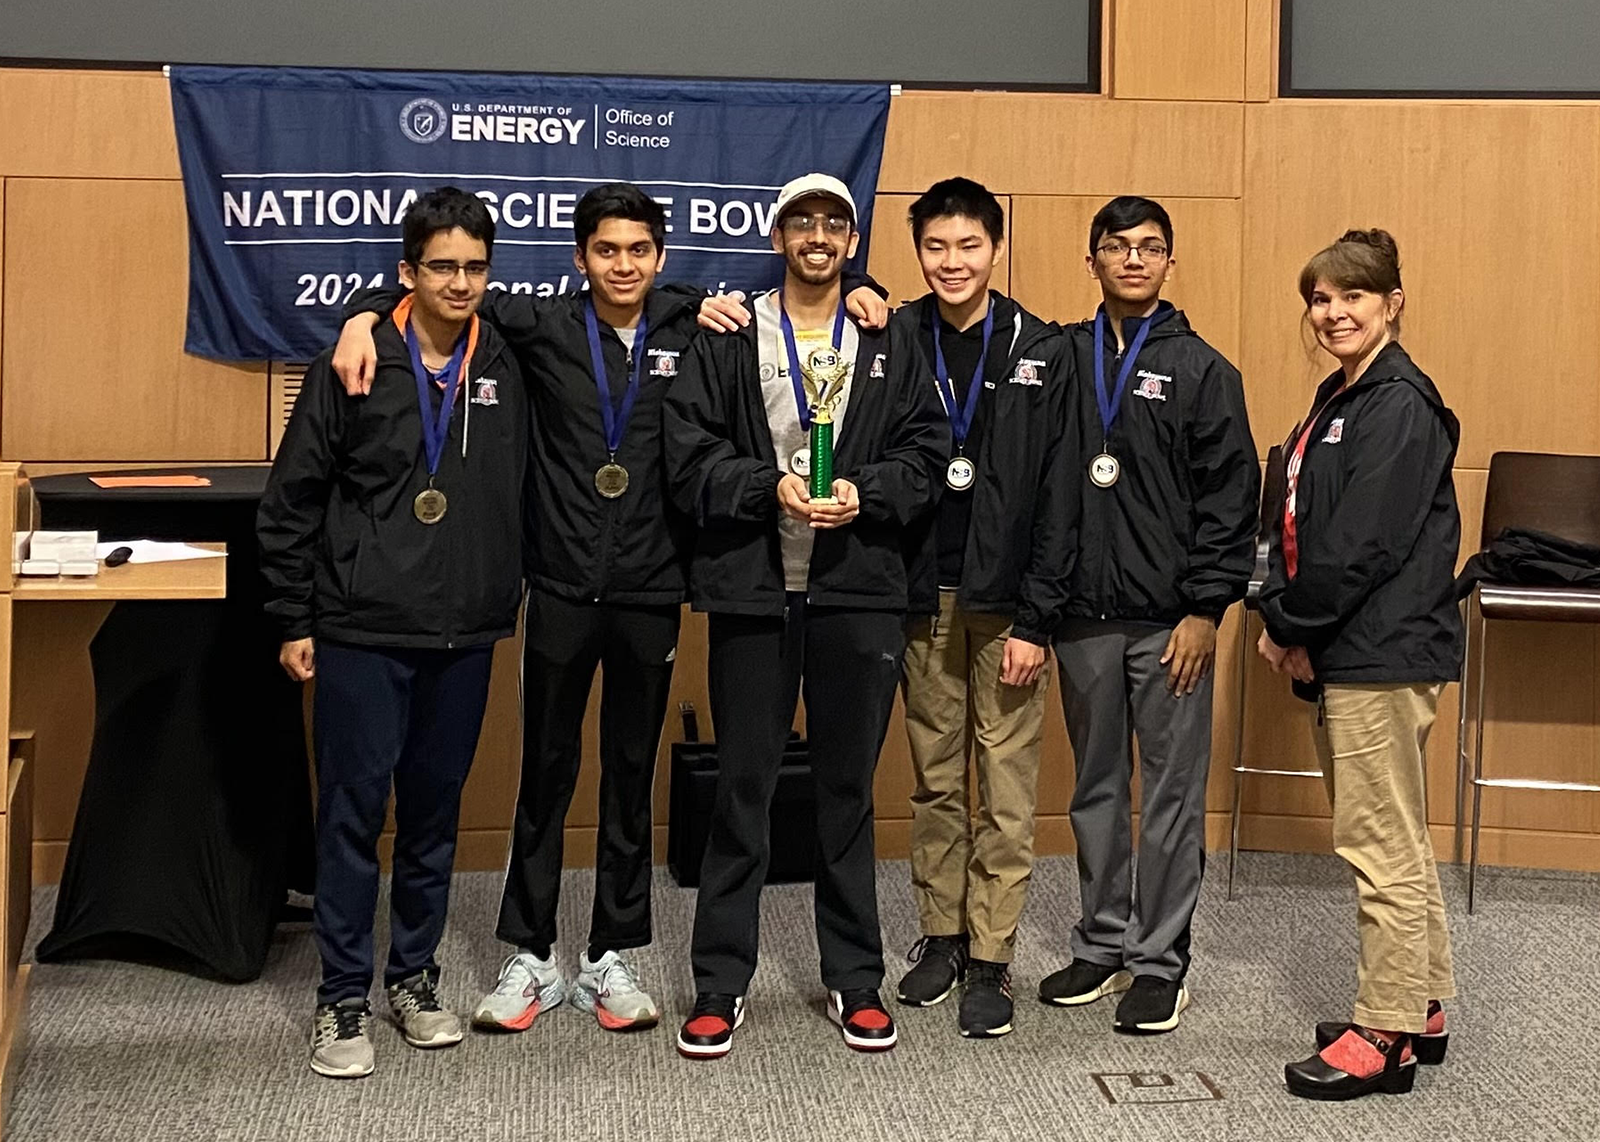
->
[496,590,680,950]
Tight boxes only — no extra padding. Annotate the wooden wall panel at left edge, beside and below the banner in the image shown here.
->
[0,178,267,462]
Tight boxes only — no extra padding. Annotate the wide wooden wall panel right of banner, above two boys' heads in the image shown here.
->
[878,91,1243,198]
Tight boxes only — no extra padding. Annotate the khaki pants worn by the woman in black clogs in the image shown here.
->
[1312,685,1456,1033]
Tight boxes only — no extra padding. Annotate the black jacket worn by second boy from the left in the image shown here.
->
[346,286,704,605]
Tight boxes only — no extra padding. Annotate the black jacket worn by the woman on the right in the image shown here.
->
[1261,342,1462,683]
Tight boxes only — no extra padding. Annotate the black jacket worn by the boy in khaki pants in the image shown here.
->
[893,293,1088,646]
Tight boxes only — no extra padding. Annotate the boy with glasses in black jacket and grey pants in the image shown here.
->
[1038,197,1261,1033]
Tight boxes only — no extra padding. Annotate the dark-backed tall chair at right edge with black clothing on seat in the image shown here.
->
[1456,453,1600,915]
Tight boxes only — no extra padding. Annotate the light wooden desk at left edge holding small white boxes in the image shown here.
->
[0,464,227,1132]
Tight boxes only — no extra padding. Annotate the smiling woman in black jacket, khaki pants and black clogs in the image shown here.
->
[1259,230,1462,1099]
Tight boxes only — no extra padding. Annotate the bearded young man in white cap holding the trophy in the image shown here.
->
[666,174,950,1059]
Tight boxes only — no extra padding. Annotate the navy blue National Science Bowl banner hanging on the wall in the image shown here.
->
[171,67,890,360]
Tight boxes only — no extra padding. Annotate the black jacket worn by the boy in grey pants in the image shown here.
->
[1067,301,1261,624]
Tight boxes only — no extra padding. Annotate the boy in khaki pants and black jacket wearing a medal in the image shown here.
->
[893,178,1080,1038]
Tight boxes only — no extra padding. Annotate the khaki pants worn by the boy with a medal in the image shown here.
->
[902,590,1050,963]
